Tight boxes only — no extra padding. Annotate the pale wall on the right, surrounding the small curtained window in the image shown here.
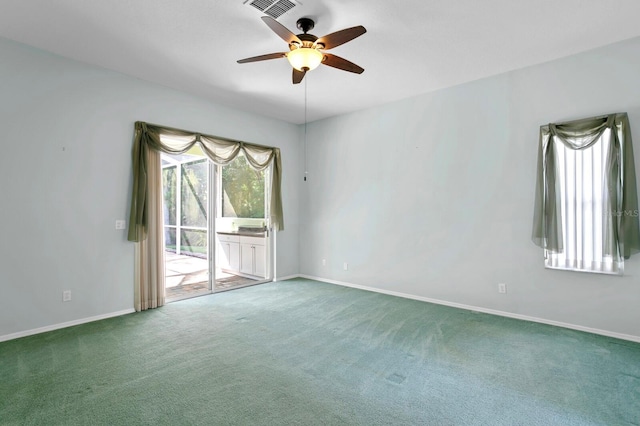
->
[300,39,640,339]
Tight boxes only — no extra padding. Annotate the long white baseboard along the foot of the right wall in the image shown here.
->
[298,274,640,343]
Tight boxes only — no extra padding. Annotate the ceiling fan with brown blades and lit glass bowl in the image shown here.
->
[238,16,367,84]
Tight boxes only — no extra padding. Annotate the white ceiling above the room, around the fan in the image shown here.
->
[0,0,640,123]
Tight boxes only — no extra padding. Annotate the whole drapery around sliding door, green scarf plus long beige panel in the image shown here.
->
[128,121,284,311]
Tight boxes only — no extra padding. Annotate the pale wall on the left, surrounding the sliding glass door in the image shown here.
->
[0,39,300,340]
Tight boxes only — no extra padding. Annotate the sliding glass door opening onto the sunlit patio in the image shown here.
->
[162,145,272,302]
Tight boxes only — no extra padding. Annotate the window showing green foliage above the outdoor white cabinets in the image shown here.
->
[220,153,265,219]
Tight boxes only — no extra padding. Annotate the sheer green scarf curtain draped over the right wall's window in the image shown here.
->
[532,113,640,260]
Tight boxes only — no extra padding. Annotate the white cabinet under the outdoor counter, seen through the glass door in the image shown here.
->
[218,234,267,278]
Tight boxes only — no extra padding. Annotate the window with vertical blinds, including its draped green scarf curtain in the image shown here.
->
[533,114,640,274]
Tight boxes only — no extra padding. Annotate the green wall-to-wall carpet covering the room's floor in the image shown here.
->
[0,279,640,426]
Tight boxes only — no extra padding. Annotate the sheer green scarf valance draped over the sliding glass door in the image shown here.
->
[128,121,284,242]
